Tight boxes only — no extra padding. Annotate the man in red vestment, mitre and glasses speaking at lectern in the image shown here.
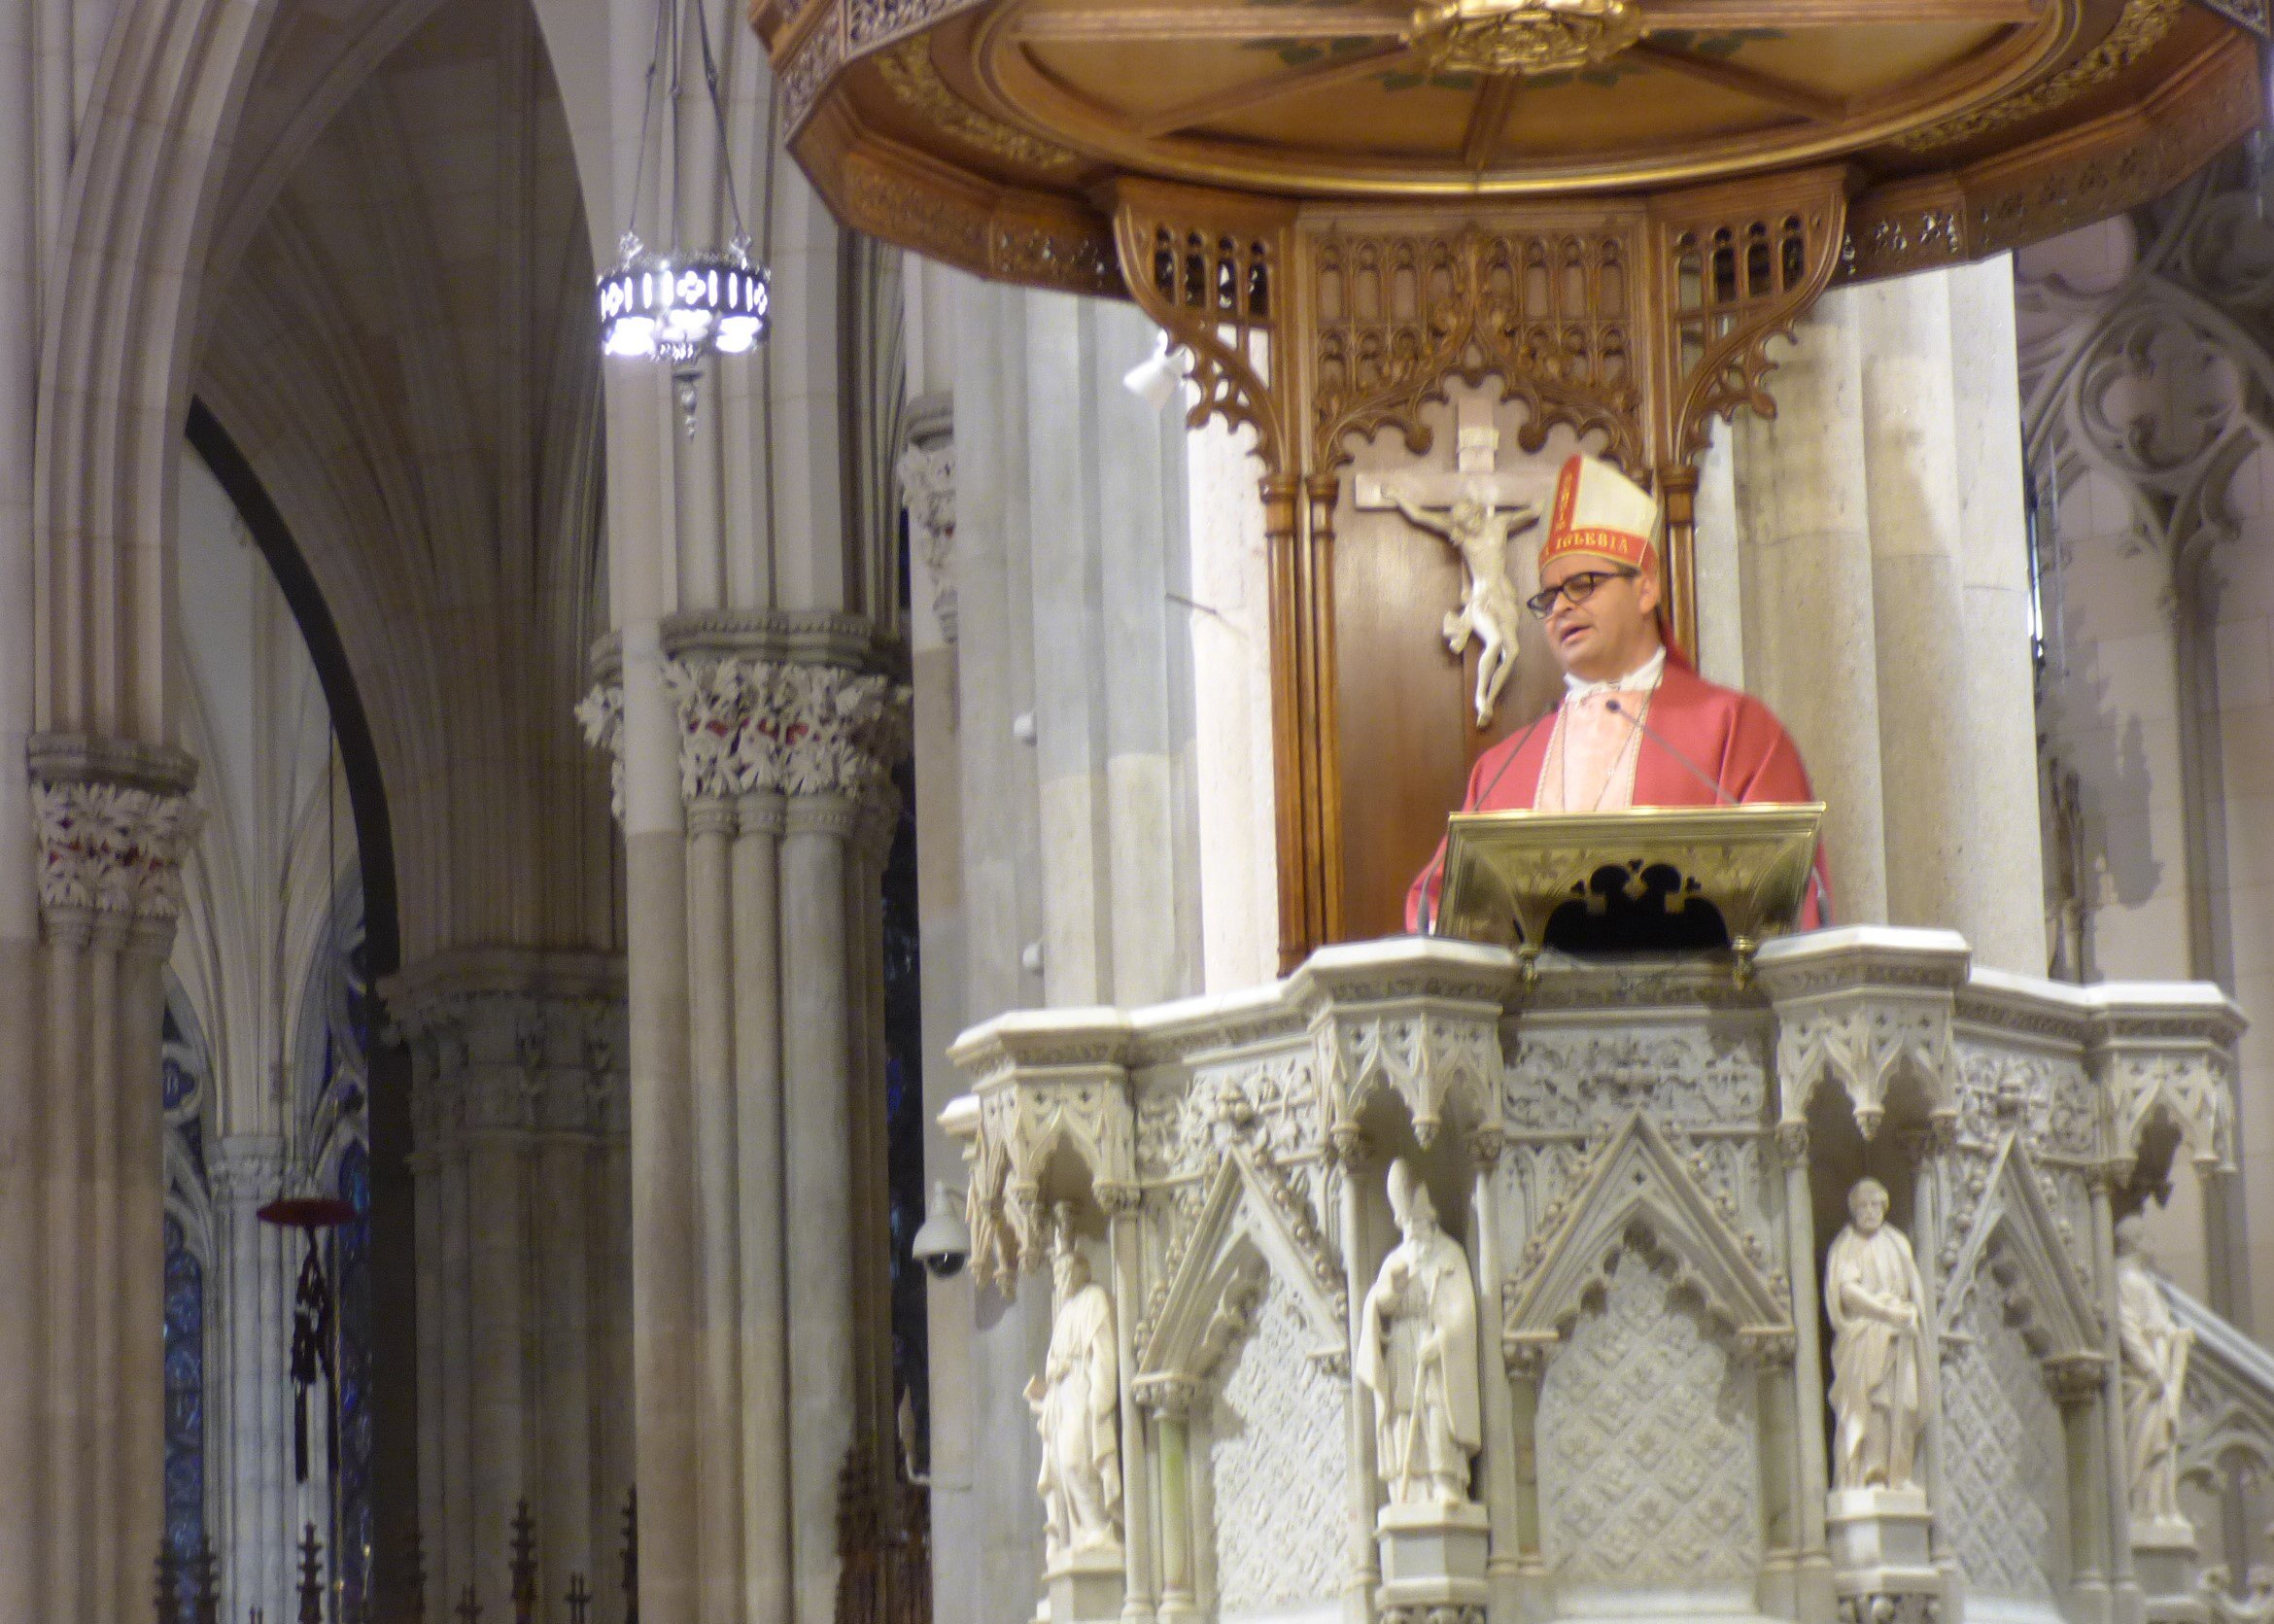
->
[1405,457,1828,930]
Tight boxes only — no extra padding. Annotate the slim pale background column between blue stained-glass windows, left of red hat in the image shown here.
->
[205,1132,300,1619]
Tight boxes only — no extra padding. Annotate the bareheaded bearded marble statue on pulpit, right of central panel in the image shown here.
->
[1824,1178,1926,1490]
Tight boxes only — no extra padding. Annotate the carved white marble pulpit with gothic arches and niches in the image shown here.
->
[944,928,2240,1624]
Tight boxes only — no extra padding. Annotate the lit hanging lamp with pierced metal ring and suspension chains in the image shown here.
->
[598,0,771,434]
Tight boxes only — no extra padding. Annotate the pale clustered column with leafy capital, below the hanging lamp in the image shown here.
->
[580,612,908,1624]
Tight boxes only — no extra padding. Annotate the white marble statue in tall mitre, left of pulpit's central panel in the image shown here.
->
[1358,1160,1485,1505]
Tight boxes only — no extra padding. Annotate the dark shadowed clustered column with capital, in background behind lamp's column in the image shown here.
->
[384,949,633,1617]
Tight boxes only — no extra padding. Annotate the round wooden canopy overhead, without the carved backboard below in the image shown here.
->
[773,0,2267,292]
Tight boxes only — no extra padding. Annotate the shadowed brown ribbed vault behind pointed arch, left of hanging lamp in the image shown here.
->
[195,0,614,960]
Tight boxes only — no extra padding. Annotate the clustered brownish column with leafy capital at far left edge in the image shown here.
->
[0,735,195,1619]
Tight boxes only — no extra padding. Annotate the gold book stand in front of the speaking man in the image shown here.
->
[1432,801,1824,981]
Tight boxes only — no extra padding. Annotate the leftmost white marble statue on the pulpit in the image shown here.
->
[1025,1217,1121,1567]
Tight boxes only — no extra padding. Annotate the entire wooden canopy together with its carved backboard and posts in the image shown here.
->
[753,0,2269,967]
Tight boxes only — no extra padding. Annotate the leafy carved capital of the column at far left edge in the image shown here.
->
[32,777,200,923]
